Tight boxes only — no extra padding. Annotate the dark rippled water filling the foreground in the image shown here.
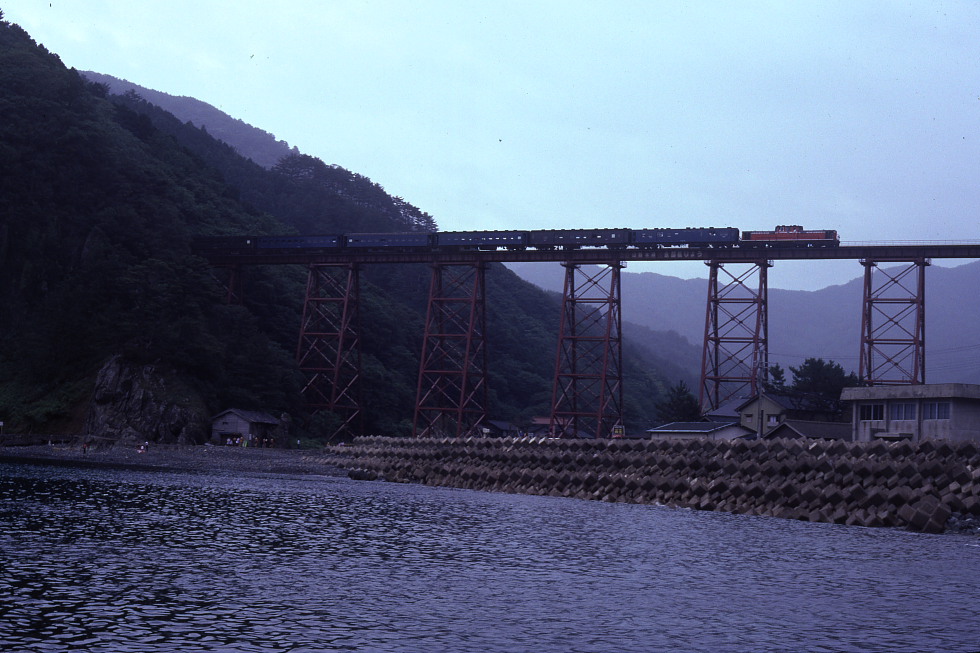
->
[0,466,980,653]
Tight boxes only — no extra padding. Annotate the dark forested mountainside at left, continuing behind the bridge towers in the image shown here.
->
[0,16,675,441]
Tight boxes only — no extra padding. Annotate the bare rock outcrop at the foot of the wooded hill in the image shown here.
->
[85,356,210,444]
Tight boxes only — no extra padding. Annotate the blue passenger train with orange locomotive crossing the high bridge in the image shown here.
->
[195,225,840,254]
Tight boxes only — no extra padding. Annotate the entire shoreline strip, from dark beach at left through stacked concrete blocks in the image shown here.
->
[9,436,980,536]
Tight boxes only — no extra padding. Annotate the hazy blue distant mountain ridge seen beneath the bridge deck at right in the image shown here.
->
[508,262,980,383]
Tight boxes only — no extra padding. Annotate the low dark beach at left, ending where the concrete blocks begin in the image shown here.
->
[0,444,347,476]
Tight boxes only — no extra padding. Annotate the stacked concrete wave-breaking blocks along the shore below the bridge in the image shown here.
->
[327,436,980,533]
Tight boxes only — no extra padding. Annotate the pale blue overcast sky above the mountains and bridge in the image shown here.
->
[0,0,980,290]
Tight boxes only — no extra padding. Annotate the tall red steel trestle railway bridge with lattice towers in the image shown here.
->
[198,243,980,438]
